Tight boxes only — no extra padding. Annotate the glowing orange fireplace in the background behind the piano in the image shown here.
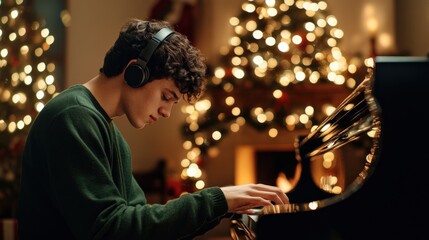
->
[235,144,365,194]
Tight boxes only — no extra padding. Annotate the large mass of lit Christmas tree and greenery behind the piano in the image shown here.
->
[177,0,365,191]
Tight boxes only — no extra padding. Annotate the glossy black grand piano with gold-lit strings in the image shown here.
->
[231,56,429,240]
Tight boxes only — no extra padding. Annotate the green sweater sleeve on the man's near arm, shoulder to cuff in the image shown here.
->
[45,106,227,239]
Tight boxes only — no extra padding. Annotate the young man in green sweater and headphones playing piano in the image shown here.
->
[18,19,289,239]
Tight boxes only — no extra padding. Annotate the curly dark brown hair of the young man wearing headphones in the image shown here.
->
[100,19,207,103]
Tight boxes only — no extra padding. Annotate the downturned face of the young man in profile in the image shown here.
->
[122,78,182,129]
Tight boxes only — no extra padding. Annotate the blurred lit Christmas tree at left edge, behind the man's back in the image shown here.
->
[0,0,57,217]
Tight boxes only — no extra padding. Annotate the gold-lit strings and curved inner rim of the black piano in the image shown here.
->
[255,66,381,214]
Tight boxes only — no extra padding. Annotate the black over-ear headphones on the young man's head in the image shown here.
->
[124,28,174,88]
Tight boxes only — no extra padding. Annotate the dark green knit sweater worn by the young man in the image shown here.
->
[18,85,227,239]
